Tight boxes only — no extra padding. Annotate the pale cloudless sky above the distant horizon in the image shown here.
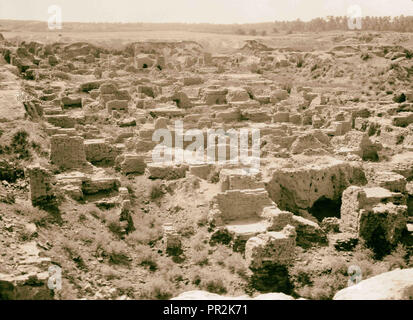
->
[0,0,413,24]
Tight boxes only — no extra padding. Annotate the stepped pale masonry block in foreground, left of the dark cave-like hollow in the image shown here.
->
[209,169,327,292]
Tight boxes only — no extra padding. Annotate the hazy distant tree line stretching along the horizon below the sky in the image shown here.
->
[0,15,413,36]
